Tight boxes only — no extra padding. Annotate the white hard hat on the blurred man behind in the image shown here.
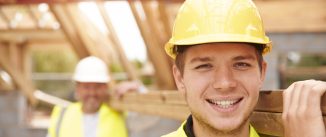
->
[73,56,110,83]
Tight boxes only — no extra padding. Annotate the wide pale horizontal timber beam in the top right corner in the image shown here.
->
[255,0,326,33]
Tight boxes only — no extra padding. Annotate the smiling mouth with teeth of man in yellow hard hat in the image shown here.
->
[206,98,243,109]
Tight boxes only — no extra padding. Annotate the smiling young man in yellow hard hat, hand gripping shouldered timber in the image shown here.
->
[164,0,326,137]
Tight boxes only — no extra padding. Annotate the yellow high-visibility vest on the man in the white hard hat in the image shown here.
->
[48,103,128,137]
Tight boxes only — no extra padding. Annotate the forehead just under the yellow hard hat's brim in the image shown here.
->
[185,43,256,61]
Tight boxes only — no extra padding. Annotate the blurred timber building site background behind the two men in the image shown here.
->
[0,0,326,137]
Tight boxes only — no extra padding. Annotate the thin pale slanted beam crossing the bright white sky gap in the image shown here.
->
[97,2,139,80]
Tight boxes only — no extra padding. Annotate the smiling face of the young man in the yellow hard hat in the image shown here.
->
[173,43,266,133]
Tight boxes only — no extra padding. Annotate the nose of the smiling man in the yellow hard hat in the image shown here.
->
[212,67,237,91]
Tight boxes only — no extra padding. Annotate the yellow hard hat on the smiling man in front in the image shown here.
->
[165,0,272,59]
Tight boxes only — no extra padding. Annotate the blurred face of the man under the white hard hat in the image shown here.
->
[76,82,108,113]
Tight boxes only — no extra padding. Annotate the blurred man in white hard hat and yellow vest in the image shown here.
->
[48,56,127,137]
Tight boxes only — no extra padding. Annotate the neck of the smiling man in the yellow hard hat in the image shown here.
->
[193,118,250,137]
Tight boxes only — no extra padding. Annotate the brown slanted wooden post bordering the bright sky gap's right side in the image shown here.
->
[128,0,175,89]
